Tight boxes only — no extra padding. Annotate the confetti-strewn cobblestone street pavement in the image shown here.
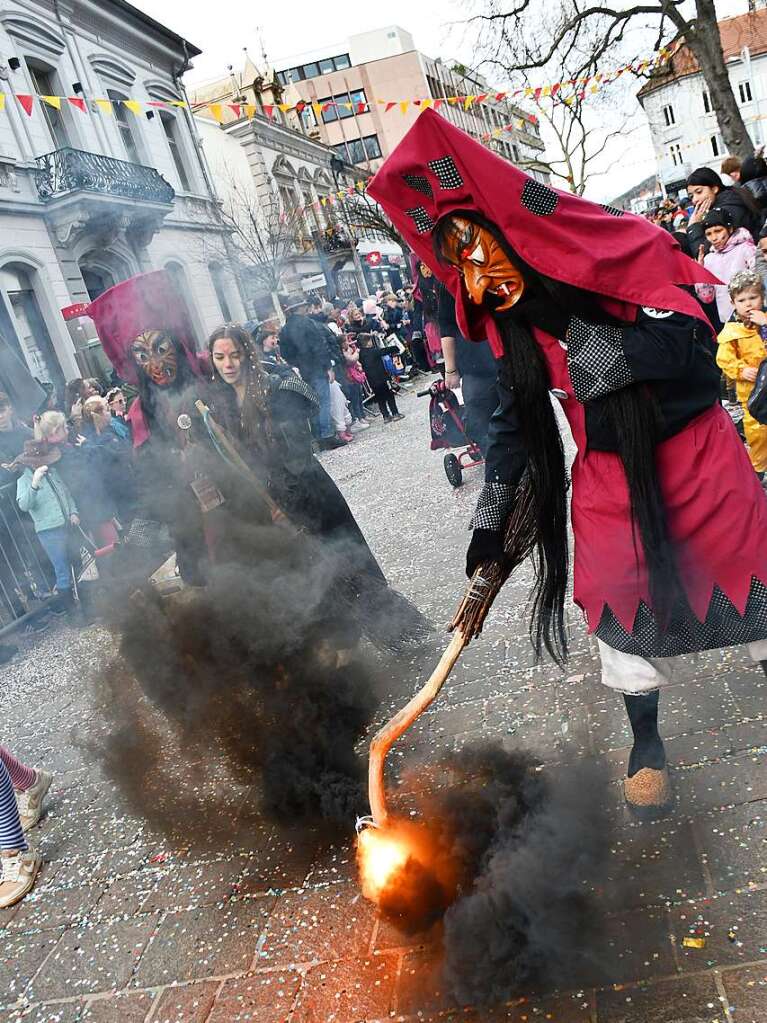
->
[0,384,767,1023]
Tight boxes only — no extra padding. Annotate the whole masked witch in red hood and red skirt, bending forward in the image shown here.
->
[369,110,767,814]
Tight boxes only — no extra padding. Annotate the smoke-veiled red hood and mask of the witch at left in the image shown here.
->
[88,270,201,388]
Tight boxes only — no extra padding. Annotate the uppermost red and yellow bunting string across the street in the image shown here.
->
[0,42,683,125]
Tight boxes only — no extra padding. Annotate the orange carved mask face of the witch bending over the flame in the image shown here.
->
[443,216,525,312]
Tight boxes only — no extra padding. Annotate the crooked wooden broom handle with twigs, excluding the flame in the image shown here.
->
[367,477,537,827]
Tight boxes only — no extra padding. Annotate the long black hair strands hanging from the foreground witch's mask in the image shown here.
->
[434,210,680,663]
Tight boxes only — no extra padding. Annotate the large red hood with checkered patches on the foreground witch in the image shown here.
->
[368,109,716,354]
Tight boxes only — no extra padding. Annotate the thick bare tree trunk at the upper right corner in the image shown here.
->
[684,0,754,160]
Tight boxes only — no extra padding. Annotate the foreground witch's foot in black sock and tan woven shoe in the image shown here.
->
[623,690,671,817]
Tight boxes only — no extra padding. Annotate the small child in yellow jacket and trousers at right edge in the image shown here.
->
[717,270,767,477]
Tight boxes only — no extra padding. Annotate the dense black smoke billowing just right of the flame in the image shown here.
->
[392,745,611,1005]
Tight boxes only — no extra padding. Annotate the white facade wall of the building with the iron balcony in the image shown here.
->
[0,0,244,390]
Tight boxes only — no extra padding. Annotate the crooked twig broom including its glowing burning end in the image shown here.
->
[357,476,536,916]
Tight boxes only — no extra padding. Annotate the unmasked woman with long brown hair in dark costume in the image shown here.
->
[208,324,425,644]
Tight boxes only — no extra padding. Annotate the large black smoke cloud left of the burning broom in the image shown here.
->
[89,526,386,842]
